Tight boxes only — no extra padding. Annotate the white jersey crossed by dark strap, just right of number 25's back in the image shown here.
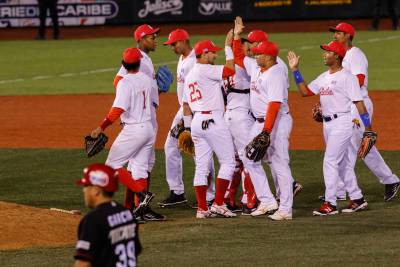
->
[226,65,250,109]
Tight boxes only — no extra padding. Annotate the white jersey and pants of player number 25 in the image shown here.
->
[183,63,235,186]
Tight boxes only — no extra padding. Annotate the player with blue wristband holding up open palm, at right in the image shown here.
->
[288,41,372,216]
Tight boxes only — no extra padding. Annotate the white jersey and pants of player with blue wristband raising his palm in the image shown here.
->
[308,69,363,206]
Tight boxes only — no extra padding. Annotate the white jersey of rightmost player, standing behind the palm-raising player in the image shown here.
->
[342,46,368,97]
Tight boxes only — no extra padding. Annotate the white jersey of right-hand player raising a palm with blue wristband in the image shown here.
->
[308,68,363,116]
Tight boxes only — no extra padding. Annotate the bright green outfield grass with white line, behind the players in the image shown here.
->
[0,31,400,95]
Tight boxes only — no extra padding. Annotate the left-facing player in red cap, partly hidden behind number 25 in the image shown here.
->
[158,29,215,207]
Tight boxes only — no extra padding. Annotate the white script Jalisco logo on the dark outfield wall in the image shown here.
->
[138,0,183,18]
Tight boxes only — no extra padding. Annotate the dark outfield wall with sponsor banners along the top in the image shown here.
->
[0,0,386,28]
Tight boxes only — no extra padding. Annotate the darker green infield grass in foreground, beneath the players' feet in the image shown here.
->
[0,149,400,266]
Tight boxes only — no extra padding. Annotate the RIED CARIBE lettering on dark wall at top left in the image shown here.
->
[0,1,119,19]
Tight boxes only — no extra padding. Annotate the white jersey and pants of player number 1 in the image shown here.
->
[106,72,155,179]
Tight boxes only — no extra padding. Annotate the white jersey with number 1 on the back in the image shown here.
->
[113,72,152,124]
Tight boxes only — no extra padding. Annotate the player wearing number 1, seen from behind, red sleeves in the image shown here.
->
[91,48,155,222]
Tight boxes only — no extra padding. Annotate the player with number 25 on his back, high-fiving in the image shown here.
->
[183,37,236,219]
